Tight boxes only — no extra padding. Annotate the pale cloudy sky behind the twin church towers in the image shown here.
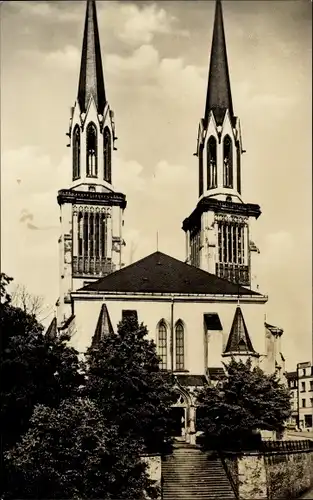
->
[0,0,312,369]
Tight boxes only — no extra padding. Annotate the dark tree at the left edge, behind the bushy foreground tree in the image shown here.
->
[0,276,84,450]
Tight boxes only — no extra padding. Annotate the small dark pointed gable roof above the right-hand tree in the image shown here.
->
[224,306,255,354]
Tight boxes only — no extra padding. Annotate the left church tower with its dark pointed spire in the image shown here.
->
[57,0,126,326]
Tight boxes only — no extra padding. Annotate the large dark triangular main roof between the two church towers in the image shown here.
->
[80,252,261,296]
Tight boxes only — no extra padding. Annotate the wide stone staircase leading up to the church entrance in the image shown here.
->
[162,443,236,500]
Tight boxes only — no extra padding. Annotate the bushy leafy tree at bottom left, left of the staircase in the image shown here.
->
[4,398,154,500]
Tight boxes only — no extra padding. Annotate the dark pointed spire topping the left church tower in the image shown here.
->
[77,0,106,114]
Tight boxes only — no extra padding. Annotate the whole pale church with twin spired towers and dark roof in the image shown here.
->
[49,0,284,443]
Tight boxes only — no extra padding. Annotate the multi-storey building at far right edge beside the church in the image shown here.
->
[286,361,313,430]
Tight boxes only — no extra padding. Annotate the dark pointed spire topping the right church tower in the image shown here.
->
[204,0,233,125]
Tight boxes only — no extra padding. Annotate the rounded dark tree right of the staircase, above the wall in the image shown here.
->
[197,359,290,450]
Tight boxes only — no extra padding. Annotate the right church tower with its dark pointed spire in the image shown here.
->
[183,0,261,288]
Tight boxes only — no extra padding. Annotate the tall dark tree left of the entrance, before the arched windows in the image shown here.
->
[86,318,177,453]
